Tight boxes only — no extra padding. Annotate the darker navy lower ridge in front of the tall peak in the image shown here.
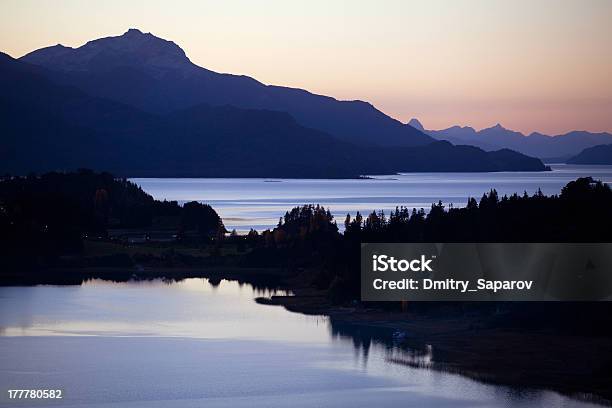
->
[0,54,545,178]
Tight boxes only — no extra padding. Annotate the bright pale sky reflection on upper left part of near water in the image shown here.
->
[0,278,310,342]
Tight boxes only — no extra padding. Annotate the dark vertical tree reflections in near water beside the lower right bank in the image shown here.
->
[329,320,433,367]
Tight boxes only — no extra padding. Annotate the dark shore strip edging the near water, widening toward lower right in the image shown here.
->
[1,265,612,406]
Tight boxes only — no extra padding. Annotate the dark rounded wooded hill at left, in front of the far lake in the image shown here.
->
[0,170,225,280]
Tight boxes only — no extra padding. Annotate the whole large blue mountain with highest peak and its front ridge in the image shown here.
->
[0,29,545,177]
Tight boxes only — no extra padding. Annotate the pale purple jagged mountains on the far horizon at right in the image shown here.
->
[416,119,612,159]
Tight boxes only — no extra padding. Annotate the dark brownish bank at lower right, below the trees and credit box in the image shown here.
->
[256,288,612,406]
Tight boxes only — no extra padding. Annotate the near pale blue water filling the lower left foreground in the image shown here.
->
[0,279,604,408]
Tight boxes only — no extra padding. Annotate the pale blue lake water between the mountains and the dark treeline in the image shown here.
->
[133,164,612,232]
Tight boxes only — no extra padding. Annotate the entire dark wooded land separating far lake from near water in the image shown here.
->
[0,170,612,401]
